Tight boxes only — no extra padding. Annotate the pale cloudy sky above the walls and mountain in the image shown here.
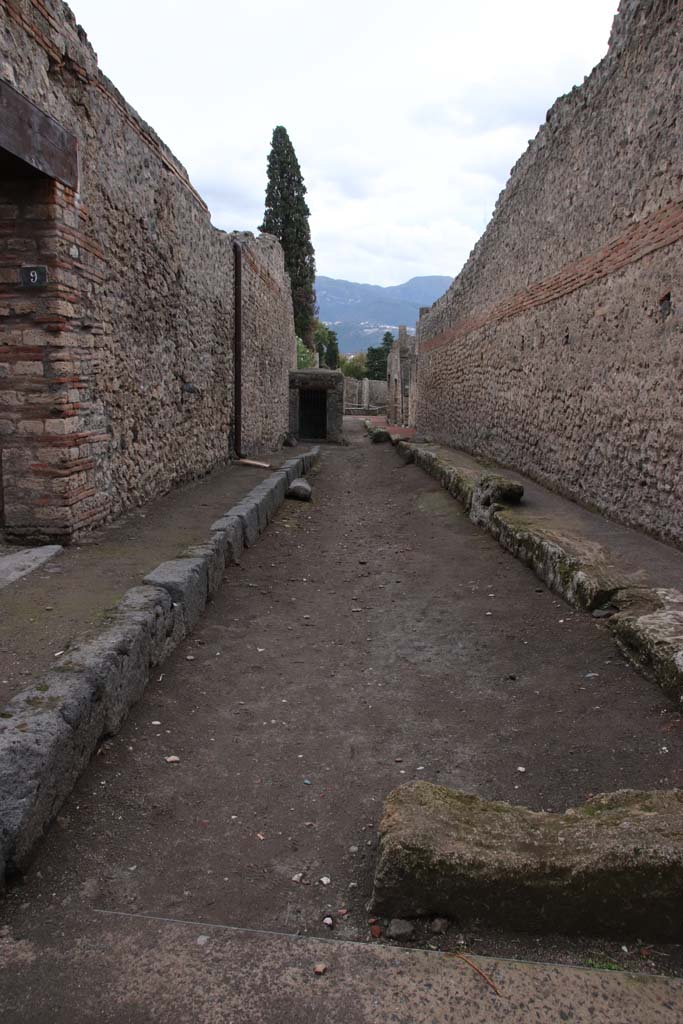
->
[70,0,616,285]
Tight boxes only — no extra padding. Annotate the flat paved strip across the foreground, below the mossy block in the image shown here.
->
[0,912,683,1024]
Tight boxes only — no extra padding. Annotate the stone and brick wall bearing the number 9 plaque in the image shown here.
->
[0,0,295,541]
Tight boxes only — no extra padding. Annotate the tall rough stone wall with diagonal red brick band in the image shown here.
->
[418,0,683,545]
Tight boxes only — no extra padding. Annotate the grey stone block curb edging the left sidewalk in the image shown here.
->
[0,447,319,892]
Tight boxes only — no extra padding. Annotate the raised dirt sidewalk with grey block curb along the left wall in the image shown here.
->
[0,449,318,889]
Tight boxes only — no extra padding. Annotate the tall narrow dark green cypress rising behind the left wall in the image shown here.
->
[259,125,315,348]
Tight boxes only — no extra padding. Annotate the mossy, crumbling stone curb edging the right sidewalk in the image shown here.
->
[387,432,683,703]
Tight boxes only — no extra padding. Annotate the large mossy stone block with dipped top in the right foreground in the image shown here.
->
[373,782,683,941]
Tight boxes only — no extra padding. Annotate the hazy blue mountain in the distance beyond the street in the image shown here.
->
[315,276,453,352]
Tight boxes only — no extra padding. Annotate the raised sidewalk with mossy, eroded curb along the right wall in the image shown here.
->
[367,418,683,705]
